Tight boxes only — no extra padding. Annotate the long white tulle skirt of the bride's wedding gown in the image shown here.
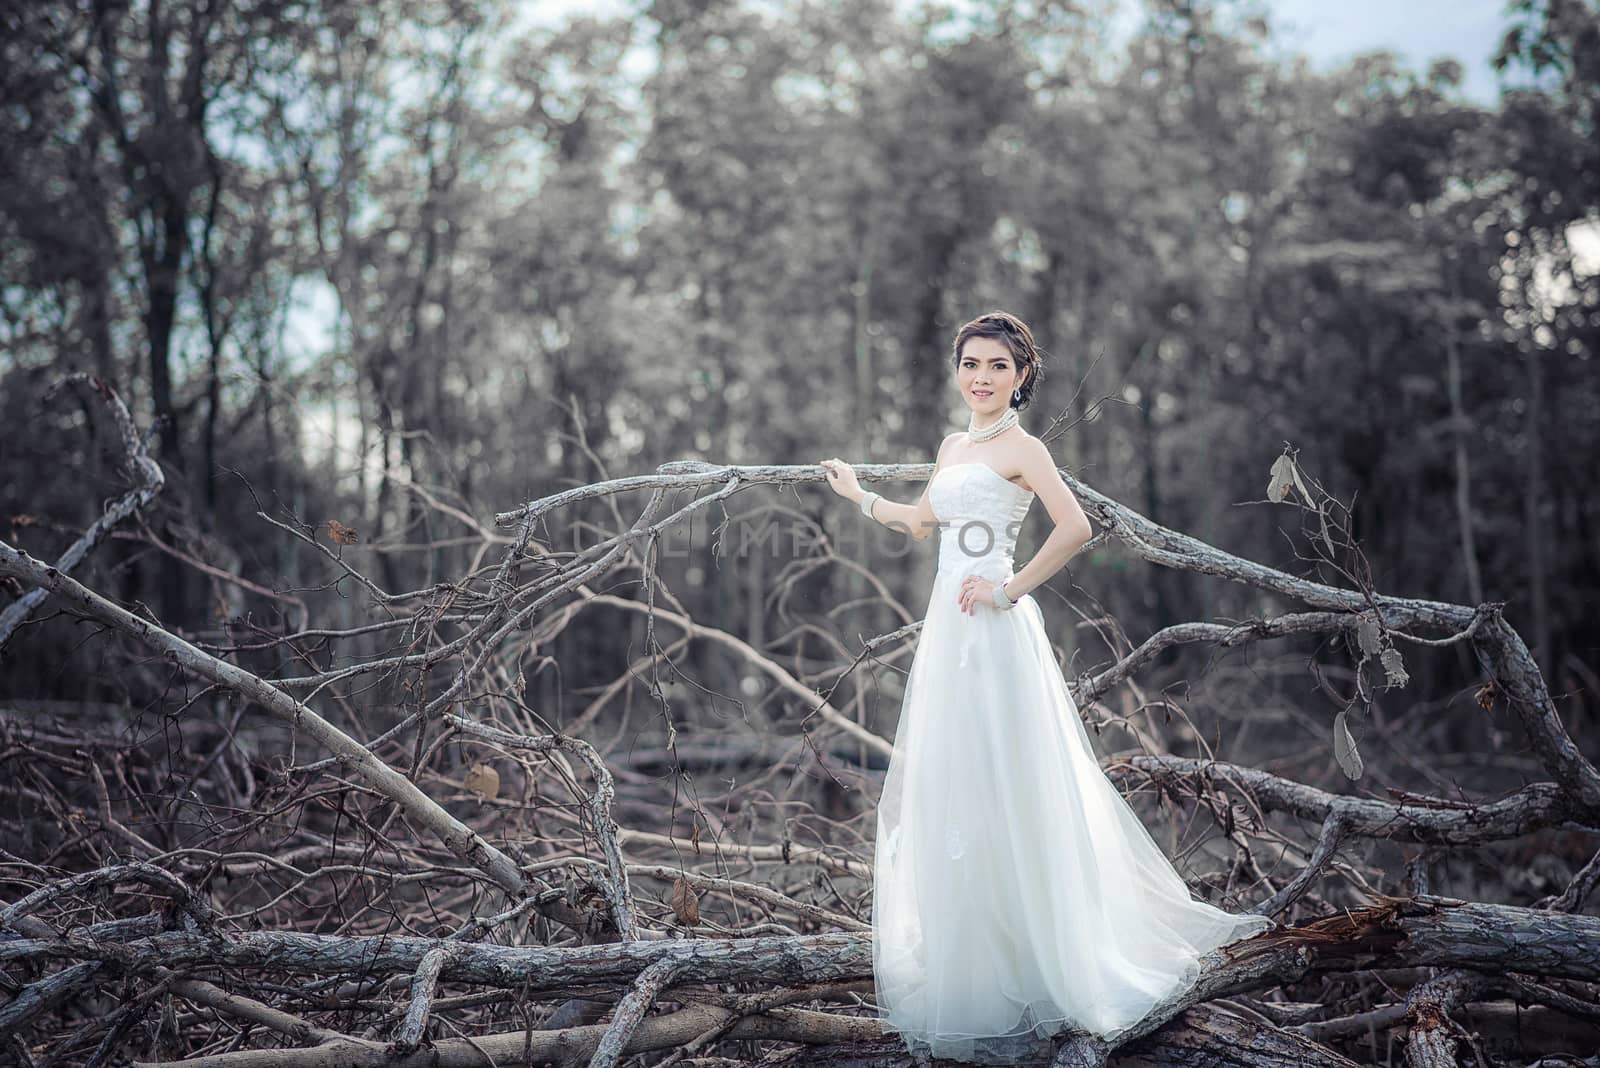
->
[872,572,1272,1063]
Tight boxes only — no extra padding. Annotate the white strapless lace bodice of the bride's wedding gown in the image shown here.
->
[928,462,1034,582]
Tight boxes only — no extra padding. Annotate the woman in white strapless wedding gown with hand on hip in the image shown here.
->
[822,312,1272,1060]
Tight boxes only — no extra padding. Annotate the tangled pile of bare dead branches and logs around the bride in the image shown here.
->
[0,377,1600,1068]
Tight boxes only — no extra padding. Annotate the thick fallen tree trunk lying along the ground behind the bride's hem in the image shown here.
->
[9,895,1600,1066]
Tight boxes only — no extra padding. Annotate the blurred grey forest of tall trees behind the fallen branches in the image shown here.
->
[0,0,1600,729]
